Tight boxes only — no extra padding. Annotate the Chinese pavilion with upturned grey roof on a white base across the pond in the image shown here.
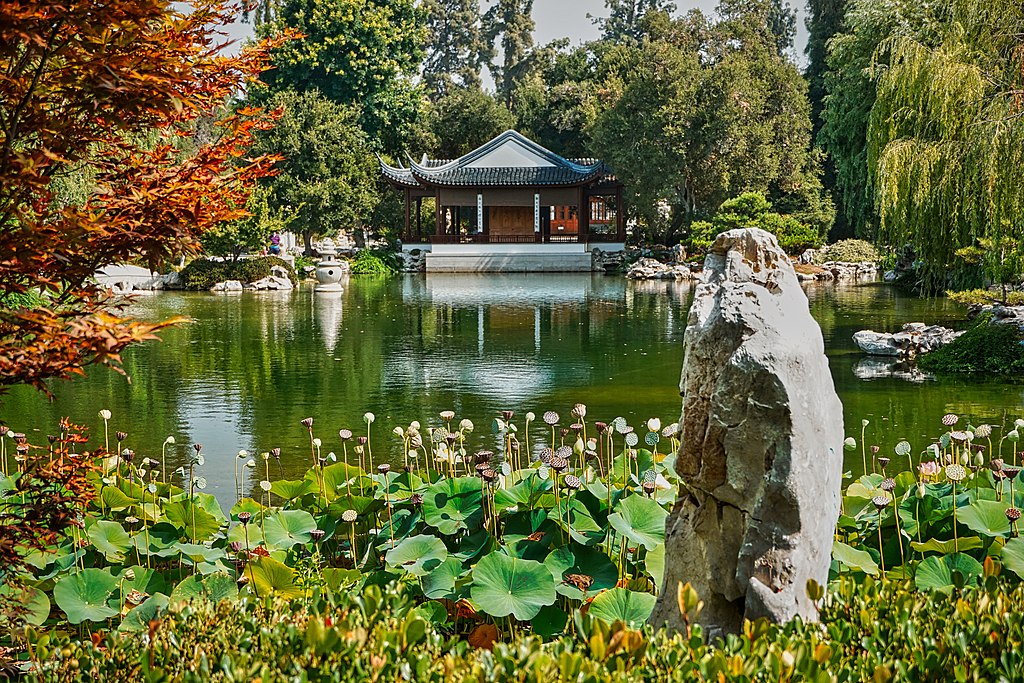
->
[381,130,626,271]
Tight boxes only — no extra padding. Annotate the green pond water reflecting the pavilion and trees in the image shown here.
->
[0,275,1024,497]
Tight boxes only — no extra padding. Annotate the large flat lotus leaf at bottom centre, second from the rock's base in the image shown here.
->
[470,552,557,622]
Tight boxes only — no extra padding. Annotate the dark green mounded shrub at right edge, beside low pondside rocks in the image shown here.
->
[918,315,1024,375]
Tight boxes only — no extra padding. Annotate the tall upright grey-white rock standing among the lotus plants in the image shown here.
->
[651,229,843,637]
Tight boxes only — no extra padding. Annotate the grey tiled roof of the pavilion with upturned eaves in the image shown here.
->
[381,130,610,188]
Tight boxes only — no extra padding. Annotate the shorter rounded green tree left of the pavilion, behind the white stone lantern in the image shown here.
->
[250,90,379,252]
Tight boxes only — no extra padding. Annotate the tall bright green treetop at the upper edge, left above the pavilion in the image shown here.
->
[260,0,426,152]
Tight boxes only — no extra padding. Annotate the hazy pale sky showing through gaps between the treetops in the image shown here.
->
[220,0,807,63]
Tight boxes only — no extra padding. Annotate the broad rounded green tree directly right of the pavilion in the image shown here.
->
[592,0,834,242]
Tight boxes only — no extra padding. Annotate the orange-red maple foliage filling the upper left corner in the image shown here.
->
[0,0,289,391]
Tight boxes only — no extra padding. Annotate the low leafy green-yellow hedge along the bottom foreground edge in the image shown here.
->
[26,577,1024,683]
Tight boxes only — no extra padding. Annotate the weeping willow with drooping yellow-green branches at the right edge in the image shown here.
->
[867,0,1024,292]
